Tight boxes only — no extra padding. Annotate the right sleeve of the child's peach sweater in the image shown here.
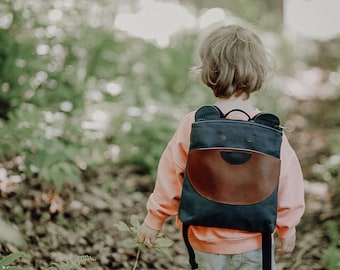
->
[277,135,305,238]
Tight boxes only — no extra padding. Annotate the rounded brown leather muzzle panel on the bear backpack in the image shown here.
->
[187,148,281,205]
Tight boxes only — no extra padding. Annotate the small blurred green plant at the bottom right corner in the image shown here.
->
[322,220,340,270]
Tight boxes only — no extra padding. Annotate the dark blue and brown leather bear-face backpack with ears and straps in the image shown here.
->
[179,106,282,270]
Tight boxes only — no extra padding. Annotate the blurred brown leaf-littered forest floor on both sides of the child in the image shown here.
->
[0,102,338,270]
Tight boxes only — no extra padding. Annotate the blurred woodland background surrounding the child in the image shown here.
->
[0,0,340,270]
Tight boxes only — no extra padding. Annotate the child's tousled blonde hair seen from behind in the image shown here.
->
[199,25,269,98]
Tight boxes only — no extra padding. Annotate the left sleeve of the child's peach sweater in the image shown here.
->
[144,113,194,230]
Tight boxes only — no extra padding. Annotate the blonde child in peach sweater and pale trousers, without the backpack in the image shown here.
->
[136,25,305,270]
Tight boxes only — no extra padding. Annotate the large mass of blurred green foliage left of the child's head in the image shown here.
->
[0,0,209,189]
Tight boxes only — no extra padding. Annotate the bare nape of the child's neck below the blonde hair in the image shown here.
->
[215,96,255,113]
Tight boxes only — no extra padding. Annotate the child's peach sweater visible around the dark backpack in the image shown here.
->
[145,110,305,254]
